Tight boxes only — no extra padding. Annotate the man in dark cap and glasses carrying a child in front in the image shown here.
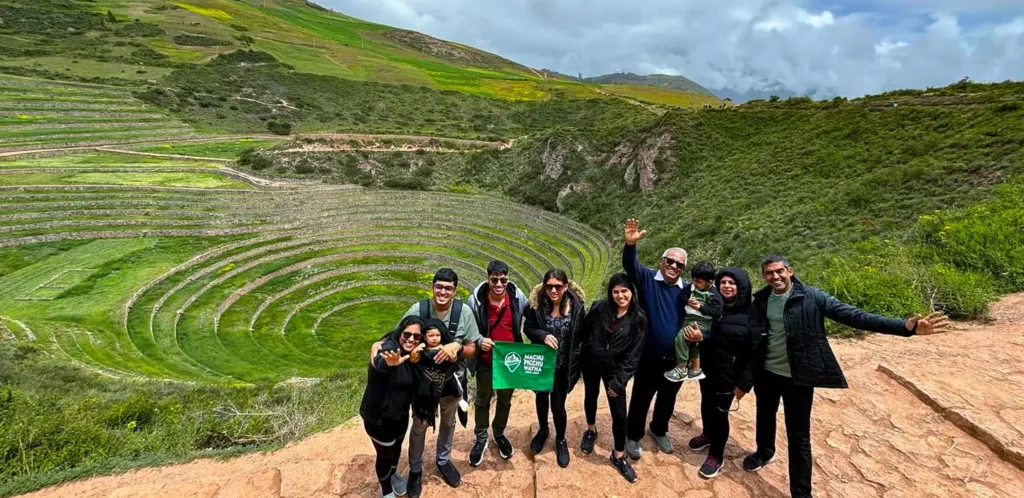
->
[371,268,480,498]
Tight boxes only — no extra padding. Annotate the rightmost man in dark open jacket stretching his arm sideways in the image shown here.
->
[735,256,949,498]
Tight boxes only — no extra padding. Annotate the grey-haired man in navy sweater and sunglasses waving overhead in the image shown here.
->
[623,218,703,460]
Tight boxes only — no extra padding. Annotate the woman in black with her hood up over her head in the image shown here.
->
[689,266,762,479]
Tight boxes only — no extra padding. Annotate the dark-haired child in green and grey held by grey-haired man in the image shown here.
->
[665,261,724,382]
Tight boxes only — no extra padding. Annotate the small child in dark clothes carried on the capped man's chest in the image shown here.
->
[410,319,465,427]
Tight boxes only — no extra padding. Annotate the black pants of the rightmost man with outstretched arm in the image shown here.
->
[754,371,814,498]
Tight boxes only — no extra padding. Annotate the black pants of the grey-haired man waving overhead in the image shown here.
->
[626,356,683,441]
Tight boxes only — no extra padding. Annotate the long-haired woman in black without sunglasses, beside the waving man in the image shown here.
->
[569,274,647,483]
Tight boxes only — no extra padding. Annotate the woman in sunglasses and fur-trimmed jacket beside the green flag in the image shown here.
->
[523,269,586,468]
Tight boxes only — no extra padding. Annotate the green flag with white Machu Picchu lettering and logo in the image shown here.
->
[490,341,558,390]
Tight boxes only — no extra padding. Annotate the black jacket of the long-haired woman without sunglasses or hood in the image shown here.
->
[568,299,647,392]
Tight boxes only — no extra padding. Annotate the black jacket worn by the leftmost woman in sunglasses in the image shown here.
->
[359,335,418,425]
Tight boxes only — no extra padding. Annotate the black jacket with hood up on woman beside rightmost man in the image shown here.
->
[700,266,763,392]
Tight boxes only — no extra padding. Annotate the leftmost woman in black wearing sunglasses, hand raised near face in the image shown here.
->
[359,316,424,497]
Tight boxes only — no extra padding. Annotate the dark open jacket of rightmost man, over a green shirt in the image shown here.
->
[752,277,914,388]
